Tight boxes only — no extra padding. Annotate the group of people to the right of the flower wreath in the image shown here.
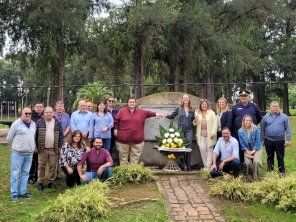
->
[171,90,291,181]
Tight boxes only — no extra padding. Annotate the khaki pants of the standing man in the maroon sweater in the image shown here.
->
[115,142,144,166]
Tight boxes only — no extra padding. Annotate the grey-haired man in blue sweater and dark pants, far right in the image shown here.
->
[261,101,292,174]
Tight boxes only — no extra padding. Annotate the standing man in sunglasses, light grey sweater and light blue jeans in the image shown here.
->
[6,107,36,202]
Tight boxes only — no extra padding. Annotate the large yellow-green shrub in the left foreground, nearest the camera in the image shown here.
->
[36,180,112,222]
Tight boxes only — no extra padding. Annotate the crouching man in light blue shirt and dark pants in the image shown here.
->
[210,127,241,178]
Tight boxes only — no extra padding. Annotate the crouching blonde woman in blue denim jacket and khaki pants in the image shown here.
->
[238,115,262,181]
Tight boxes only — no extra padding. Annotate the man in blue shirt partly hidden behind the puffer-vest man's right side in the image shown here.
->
[53,101,70,180]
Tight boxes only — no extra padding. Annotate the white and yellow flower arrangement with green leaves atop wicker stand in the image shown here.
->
[155,122,190,159]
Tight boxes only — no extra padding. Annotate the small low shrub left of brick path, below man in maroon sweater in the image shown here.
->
[107,164,156,186]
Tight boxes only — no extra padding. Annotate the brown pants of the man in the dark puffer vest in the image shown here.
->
[38,148,57,183]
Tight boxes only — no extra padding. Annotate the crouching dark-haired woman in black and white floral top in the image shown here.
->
[59,130,86,188]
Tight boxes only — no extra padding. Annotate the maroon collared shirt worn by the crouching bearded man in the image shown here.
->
[77,148,113,172]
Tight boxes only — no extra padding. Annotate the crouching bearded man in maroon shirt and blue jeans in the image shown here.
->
[77,137,113,183]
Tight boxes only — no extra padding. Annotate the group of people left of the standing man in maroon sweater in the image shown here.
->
[6,97,117,202]
